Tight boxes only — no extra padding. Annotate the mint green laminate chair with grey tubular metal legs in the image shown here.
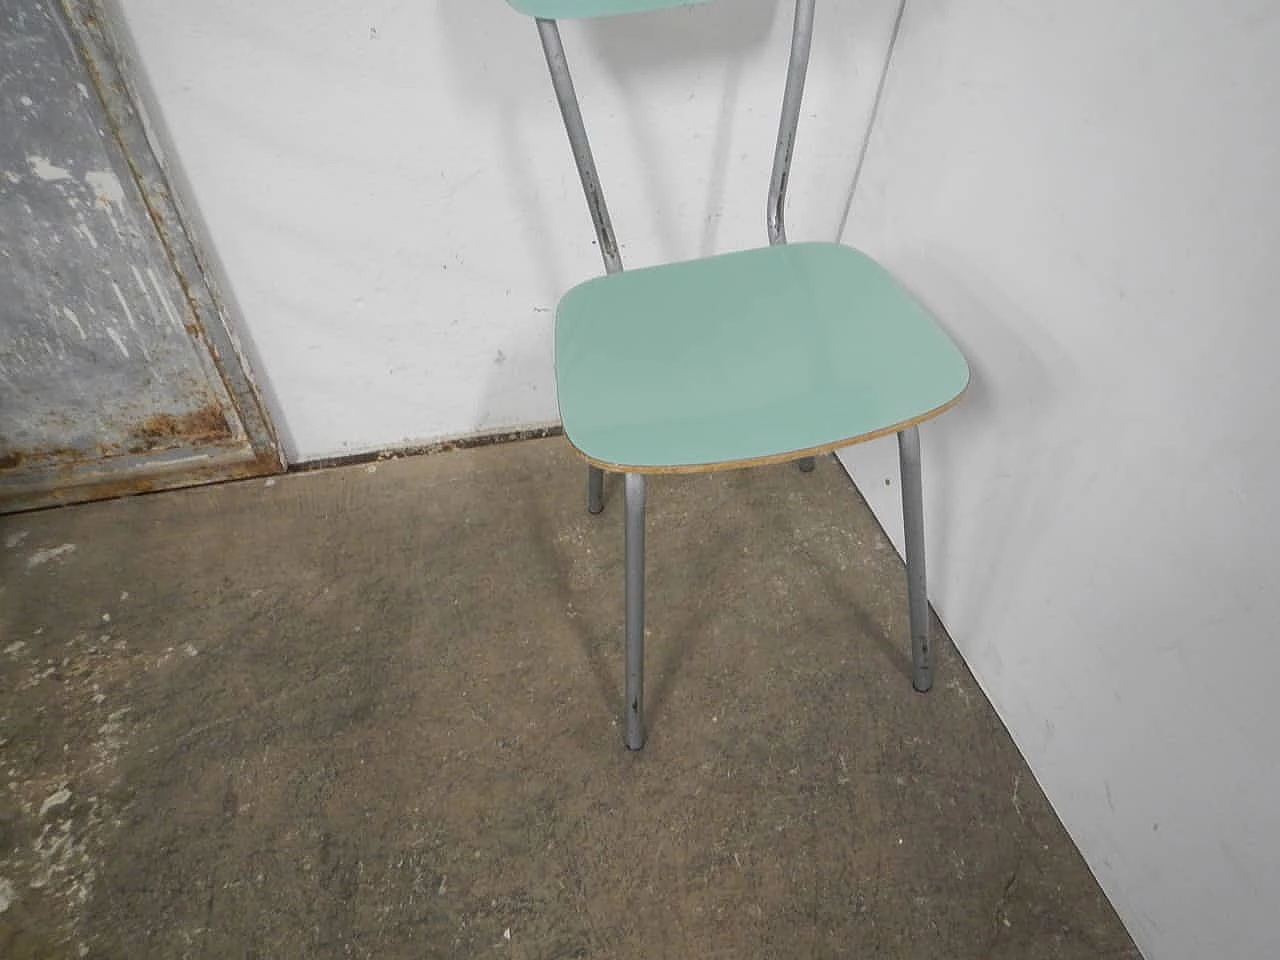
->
[508,0,969,750]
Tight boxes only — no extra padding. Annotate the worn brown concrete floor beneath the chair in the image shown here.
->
[0,439,1139,960]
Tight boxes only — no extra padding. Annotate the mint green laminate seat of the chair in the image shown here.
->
[556,243,969,472]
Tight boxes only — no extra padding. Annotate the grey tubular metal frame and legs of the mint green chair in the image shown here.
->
[535,0,933,750]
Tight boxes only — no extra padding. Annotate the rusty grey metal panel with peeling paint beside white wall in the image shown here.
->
[0,0,280,511]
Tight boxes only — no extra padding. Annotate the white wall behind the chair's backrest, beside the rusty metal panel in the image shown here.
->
[115,0,897,461]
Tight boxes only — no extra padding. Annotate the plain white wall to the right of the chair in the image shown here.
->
[847,0,1280,960]
